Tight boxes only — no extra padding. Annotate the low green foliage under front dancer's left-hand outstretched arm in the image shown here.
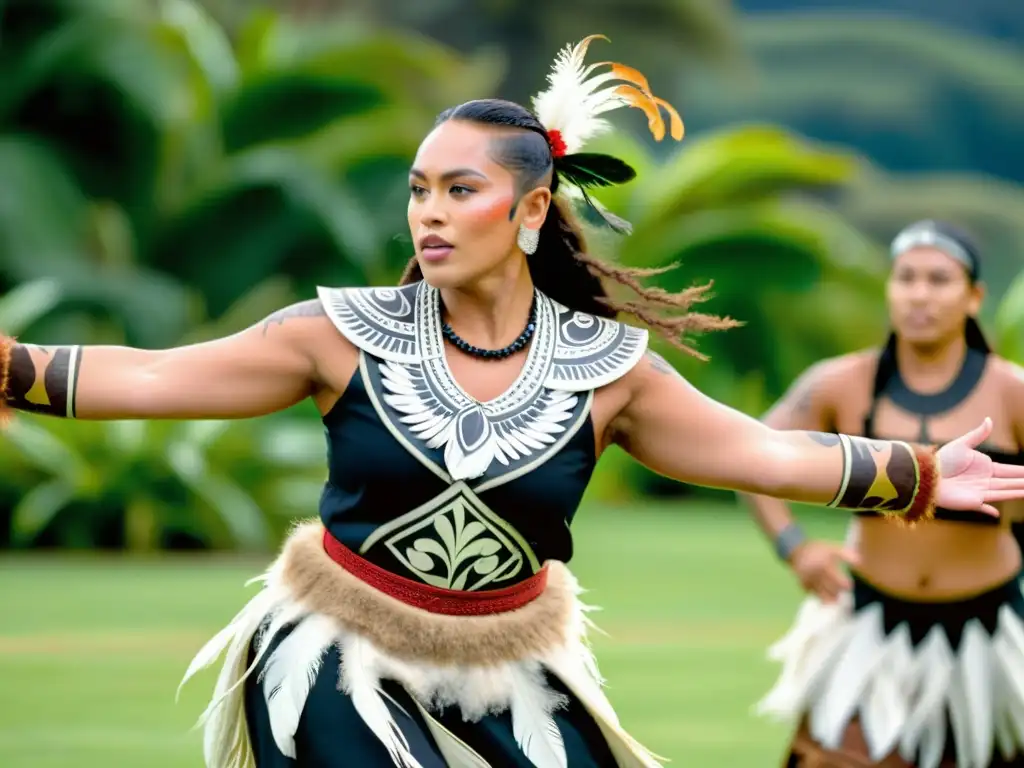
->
[3,417,324,551]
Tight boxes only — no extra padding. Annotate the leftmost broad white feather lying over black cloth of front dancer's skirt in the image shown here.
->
[262,613,339,758]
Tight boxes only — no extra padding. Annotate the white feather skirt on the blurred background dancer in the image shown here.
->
[757,581,1024,768]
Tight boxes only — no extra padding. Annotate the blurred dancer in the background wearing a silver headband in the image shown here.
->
[753,221,1024,768]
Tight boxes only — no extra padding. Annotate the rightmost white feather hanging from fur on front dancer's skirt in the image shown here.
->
[509,664,568,768]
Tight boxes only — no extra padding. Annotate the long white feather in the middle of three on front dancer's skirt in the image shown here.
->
[340,635,423,768]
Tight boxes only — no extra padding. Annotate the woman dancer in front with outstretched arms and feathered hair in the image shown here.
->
[4,38,1024,768]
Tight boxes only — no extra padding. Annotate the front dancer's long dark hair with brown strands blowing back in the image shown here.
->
[400,98,740,359]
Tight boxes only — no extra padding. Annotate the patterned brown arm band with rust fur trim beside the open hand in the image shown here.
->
[814,434,939,522]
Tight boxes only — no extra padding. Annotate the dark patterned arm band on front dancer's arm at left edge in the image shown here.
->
[0,338,82,419]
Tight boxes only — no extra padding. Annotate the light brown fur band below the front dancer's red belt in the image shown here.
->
[271,521,579,667]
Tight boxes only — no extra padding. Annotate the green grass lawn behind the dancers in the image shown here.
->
[0,505,845,768]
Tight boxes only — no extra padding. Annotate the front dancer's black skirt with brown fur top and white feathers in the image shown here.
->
[182,522,660,768]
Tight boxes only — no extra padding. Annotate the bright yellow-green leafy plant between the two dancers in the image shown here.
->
[581,126,886,499]
